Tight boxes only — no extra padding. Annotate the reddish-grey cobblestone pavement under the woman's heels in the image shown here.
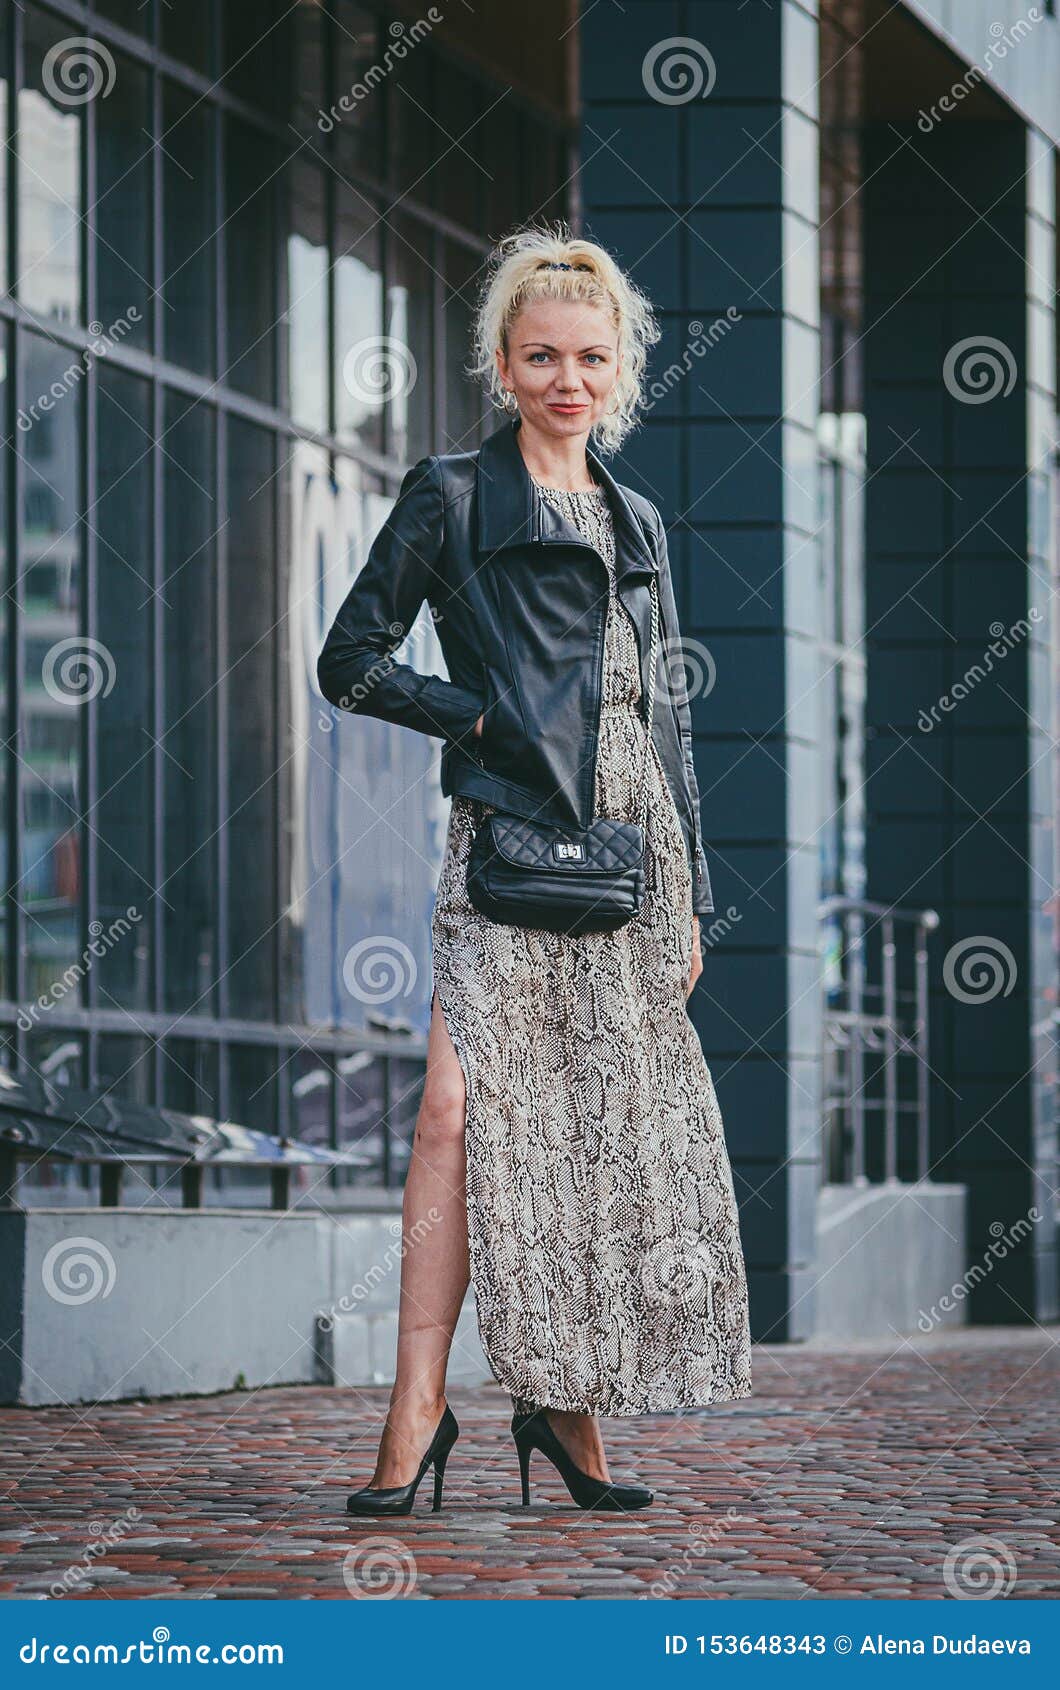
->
[0,1330,1060,1600]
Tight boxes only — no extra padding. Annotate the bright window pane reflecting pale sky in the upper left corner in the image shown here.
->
[19,12,82,323]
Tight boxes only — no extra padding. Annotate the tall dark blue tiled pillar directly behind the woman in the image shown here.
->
[580,0,820,1342]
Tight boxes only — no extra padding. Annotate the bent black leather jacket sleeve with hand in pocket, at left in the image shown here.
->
[316,458,484,742]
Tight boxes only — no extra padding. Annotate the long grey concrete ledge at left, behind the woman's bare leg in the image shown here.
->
[0,1193,492,1404]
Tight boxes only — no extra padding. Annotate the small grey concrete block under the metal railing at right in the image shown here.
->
[813,1181,967,1340]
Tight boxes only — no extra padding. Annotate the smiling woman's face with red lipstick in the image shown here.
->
[497,299,619,438]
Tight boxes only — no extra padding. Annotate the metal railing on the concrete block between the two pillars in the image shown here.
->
[818,897,938,1185]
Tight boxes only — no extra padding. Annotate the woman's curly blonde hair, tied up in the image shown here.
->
[468,223,659,451]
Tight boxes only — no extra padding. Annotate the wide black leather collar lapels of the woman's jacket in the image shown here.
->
[475,417,658,576]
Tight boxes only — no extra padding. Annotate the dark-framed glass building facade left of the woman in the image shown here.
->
[0,0,566,1185]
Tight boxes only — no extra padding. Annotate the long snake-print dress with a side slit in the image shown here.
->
[433,488,751,1415]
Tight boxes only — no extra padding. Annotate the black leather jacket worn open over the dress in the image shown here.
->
[316,421,713,916]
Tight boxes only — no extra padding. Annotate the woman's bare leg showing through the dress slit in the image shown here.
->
[370,997,468,1489]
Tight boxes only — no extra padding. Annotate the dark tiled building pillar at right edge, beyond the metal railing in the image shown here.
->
[864,119,1057,1323]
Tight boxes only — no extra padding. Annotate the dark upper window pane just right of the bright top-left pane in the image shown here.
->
[96,59,154,346]
